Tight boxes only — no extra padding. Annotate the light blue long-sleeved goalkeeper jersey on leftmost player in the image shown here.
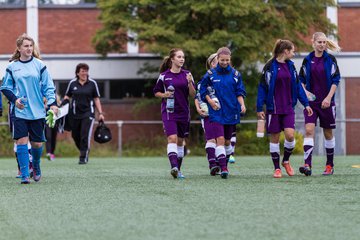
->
[0,57,55,120]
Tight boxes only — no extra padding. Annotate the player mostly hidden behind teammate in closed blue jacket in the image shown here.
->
[195,53,220,176]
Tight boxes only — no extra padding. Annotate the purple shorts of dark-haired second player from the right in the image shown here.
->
[266,113,295,133]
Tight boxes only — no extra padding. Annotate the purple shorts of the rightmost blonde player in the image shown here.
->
[304,102,336,129]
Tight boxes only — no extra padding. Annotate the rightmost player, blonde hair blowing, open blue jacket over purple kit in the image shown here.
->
[299,32,340,176]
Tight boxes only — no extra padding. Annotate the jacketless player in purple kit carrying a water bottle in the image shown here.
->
[153,48,195,178]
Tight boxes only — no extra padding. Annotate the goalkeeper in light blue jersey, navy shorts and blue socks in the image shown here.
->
[0,34,57,184]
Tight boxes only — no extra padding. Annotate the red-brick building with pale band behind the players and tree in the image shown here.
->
[0,0,360,154]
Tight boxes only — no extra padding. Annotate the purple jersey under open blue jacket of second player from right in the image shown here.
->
[272,62,294,114]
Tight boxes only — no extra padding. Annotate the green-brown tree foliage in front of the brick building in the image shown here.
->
[93,0,335,74]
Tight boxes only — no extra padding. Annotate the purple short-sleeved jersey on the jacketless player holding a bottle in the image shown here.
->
[153,69,195,121]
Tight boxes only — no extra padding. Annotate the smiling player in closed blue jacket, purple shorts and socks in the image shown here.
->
[200,47,246,179]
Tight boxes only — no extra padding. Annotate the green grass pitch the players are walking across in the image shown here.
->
[0,156,360,240]
